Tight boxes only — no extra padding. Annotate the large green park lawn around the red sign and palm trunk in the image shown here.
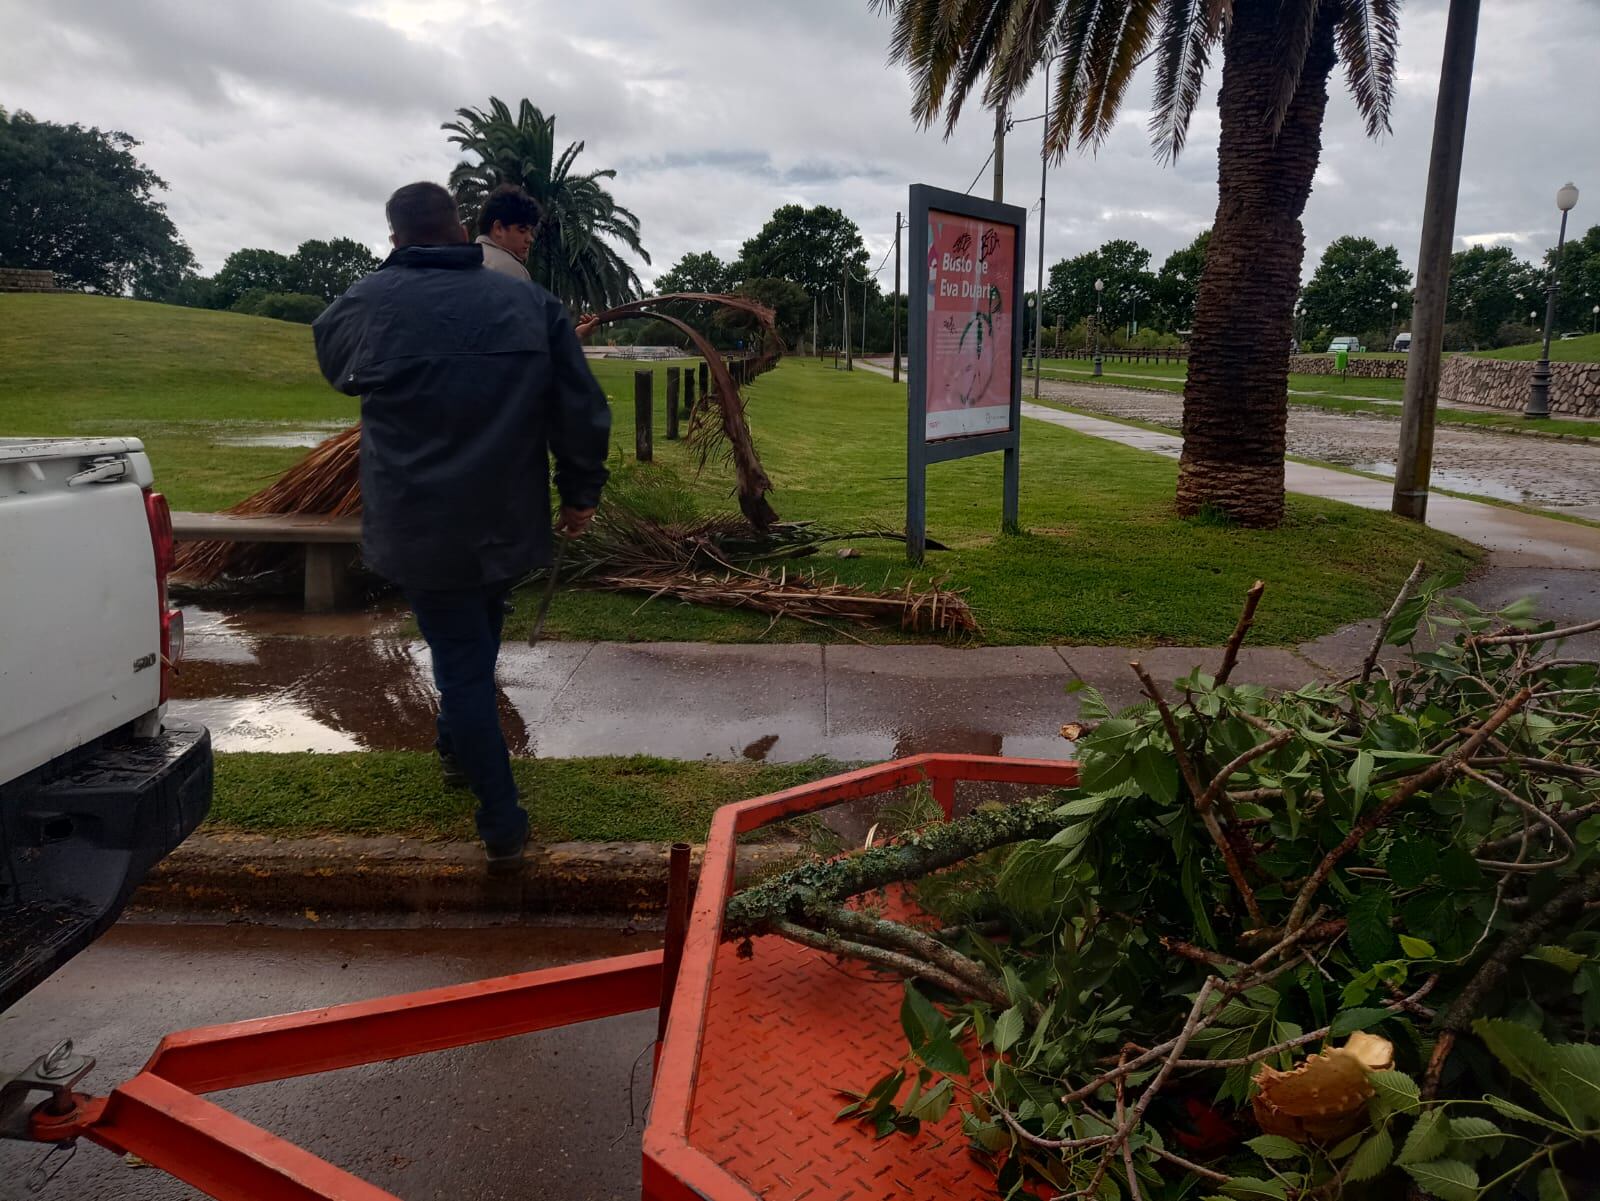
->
[0,296,1477,644]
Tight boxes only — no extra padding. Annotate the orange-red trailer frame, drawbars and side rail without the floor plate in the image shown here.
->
[30,755,1077,1201]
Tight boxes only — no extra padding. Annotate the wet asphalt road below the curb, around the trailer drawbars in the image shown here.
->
[0,923,658,1201]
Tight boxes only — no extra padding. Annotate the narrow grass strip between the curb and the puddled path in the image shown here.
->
[208,752,846,843]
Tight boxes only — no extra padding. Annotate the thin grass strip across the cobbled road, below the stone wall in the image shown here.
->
[1024,361,1600,438]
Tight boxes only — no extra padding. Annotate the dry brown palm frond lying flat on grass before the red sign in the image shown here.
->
[584,568,979,636]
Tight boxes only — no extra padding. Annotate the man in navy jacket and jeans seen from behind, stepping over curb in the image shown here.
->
[312,184,611,867]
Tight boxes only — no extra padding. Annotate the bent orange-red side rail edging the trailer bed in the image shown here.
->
[643,755,1078,1201]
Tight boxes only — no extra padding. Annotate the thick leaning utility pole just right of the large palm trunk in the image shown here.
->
[1390,0,1478,521]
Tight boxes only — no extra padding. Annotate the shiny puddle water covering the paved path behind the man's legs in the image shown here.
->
[171,601,1072,763]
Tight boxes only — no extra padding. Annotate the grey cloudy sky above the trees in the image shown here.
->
[0,0,1600,283]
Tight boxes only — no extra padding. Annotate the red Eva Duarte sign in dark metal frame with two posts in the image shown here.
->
[906,184,1027,563]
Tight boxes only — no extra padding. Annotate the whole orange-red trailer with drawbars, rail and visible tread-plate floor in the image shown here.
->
[18,755,1077,1201]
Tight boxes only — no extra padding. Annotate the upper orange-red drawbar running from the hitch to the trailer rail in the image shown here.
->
[144,952,661,1092]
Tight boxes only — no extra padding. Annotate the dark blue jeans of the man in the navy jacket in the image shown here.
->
[406,582,528,848]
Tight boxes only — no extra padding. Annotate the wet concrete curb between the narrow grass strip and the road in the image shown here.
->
[133,835,805,916]
